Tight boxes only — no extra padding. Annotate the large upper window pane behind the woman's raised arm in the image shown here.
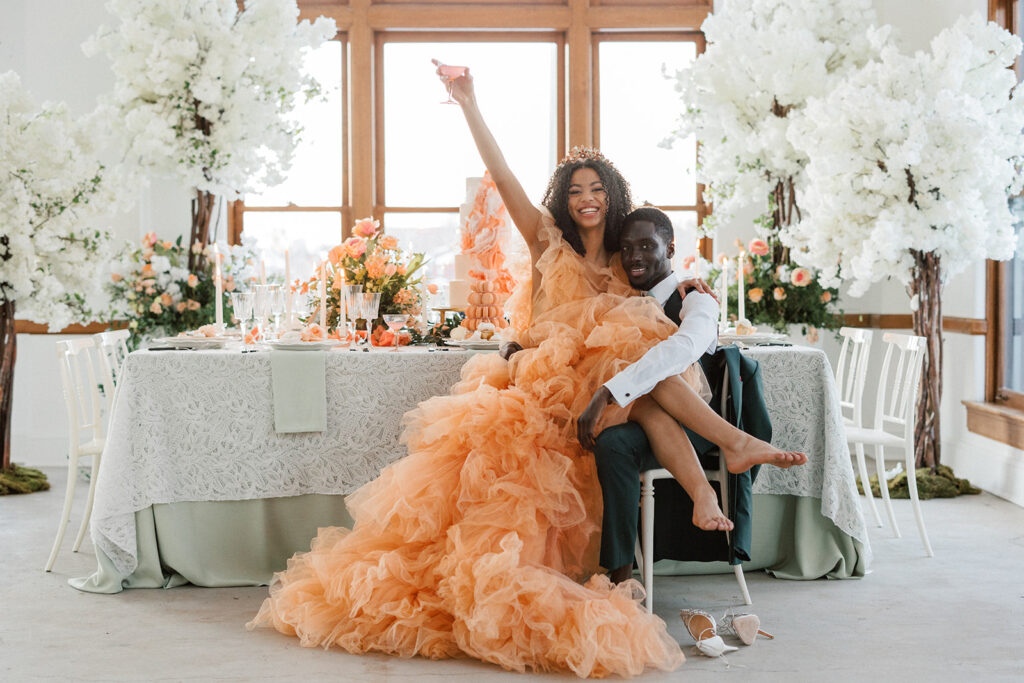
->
[383,43,557,207]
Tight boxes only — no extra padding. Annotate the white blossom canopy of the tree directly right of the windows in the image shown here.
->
[674,0,874,231]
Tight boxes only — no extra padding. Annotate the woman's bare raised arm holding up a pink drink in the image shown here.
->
[433,59,544,263]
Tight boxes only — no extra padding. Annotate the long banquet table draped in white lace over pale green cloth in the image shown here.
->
[70,346,870,593]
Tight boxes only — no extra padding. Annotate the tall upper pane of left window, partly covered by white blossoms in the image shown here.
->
[246,40,344,206]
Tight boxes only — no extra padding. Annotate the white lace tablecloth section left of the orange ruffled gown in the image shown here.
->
[91,347,470,577]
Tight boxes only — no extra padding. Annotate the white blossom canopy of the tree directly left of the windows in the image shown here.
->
[83,0,337,198]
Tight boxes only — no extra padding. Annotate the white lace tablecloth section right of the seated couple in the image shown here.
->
[743,346,870,559]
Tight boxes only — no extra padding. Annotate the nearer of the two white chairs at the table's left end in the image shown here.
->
[46,337,103,571]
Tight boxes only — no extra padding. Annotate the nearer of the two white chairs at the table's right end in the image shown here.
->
[846,333,935,557]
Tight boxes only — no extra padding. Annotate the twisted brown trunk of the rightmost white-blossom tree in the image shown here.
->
[909,251,942,472]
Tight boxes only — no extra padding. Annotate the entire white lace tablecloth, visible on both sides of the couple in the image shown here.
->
[92,347,869,577]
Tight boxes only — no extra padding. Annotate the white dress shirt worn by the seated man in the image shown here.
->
[604,272,719,408]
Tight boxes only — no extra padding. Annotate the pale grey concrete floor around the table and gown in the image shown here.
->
[0,469,1024,683]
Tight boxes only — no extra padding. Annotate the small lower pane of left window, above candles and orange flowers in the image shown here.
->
[242,211,341,280]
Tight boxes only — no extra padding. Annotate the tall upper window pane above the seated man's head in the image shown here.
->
[598,41,696,205]
